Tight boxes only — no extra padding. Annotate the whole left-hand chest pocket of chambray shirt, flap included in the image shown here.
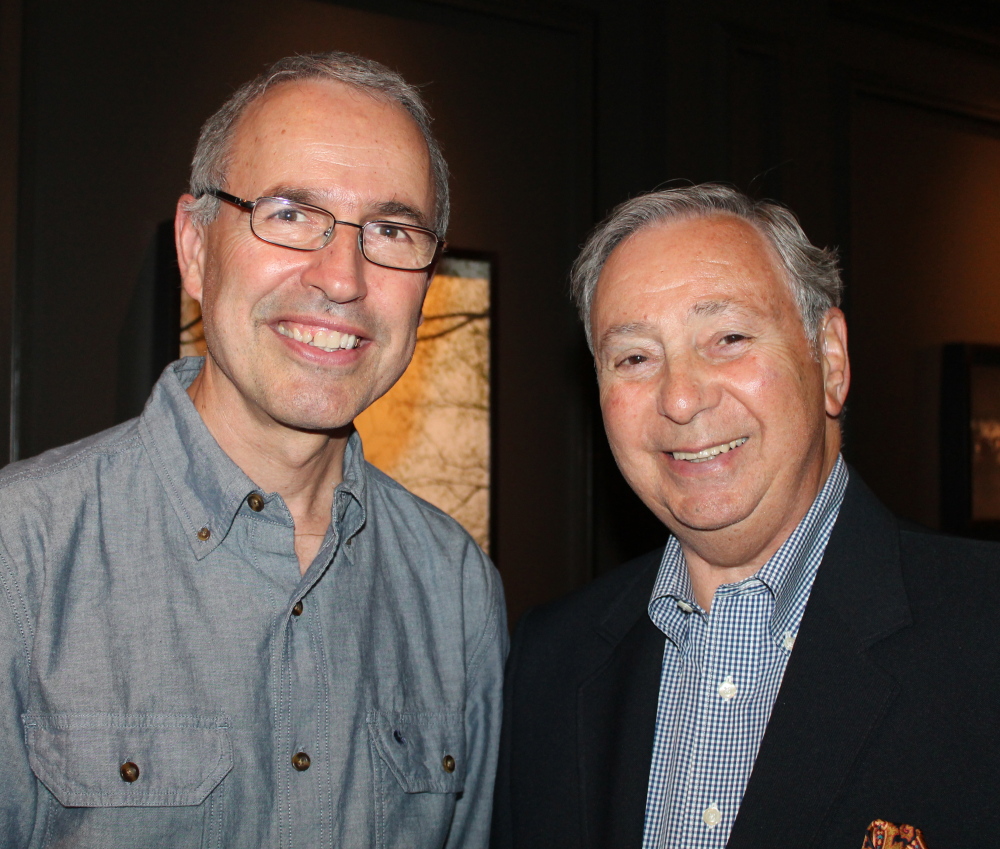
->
[24,713,233,847]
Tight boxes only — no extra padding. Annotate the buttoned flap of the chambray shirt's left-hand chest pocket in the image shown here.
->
[24,713,233,807]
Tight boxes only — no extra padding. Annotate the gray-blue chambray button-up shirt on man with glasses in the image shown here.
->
[0,359,507,849]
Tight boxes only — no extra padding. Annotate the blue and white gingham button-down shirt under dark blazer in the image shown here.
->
[642,457,847,849]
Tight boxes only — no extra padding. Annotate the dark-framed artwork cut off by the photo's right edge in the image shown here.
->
[941,344,1000,539]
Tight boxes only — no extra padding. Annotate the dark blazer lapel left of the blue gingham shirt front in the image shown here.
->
[577,549,665,849]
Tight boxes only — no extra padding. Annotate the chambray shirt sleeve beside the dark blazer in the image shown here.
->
[445,547,509,849]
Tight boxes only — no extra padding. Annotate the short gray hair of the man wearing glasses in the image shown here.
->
[188,51,450,237]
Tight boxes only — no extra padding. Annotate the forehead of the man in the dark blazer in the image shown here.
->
[593,215,792,325]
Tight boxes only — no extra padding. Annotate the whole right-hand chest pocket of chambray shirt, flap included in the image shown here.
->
[368,711,466,847]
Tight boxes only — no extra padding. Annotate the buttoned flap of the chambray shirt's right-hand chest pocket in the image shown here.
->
[368,711,465,793]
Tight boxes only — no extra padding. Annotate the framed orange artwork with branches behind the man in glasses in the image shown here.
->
[180,249,496,553]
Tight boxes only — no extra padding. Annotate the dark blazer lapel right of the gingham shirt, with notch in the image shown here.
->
[728,471,910,849]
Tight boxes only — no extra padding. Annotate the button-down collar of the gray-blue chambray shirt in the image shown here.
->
[139,357,367,560]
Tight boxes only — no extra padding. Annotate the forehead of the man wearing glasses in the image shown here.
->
[227,79,433,210]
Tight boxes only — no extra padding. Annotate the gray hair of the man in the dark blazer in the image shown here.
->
[570,183,844,351]
